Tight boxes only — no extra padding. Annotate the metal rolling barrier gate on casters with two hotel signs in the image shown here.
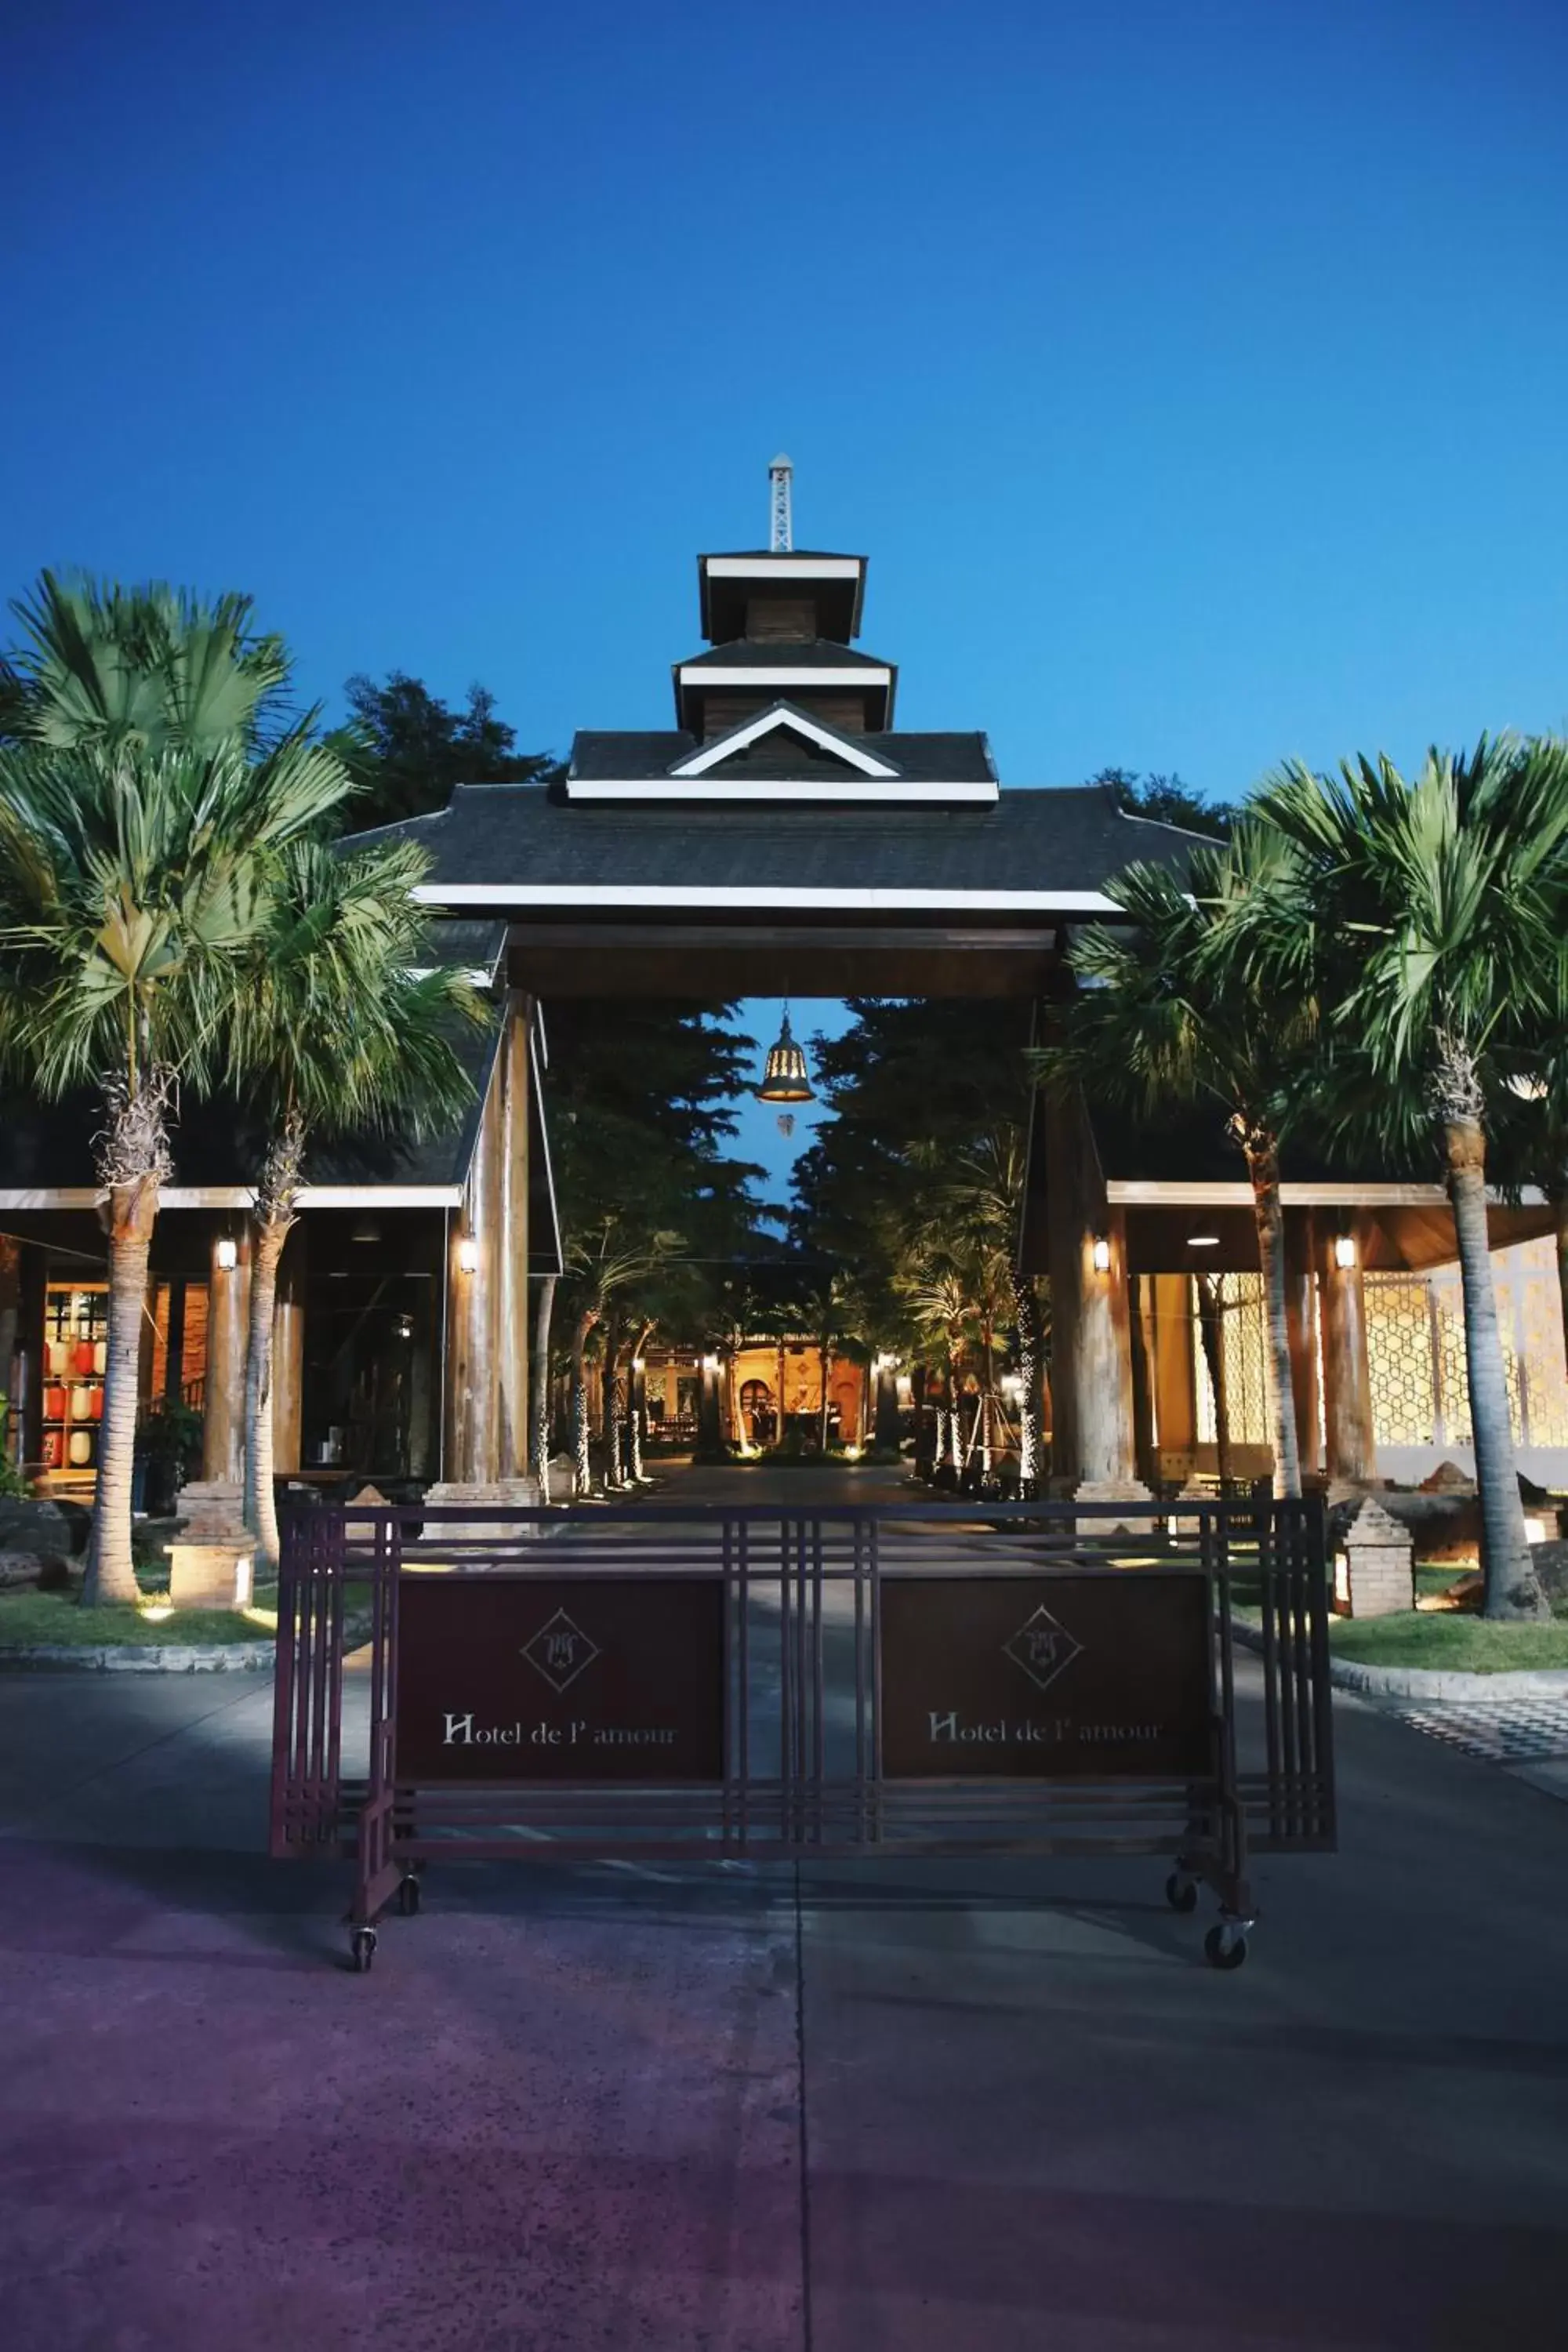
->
[270,1501,1335,1969]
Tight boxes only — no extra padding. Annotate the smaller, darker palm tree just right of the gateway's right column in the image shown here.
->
[1034,823,1316,1496]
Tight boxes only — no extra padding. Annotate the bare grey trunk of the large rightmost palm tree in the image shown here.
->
[1441,1101,1547,1618]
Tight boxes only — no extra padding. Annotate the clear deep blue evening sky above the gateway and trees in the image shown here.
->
[0,0,1568,1204]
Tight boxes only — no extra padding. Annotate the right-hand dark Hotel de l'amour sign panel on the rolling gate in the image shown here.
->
[881,1571,1213,1780]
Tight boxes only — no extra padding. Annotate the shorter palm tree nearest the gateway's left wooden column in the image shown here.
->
[233,840,487,1566]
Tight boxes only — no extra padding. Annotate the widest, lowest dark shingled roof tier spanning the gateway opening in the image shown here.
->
[361,786,1199,891]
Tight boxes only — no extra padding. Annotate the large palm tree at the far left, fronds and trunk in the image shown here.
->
[0,734,348,1602]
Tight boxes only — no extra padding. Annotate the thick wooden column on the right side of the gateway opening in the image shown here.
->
[1044,1094,1145,1498]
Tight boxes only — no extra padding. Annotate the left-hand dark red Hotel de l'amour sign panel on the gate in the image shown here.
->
[397,1573,724,1783]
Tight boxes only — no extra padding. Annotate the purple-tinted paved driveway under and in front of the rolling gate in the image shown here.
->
[0,1472,1568,2352]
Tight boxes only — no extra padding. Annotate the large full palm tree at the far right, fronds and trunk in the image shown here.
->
[1253,736,1568,1618]
